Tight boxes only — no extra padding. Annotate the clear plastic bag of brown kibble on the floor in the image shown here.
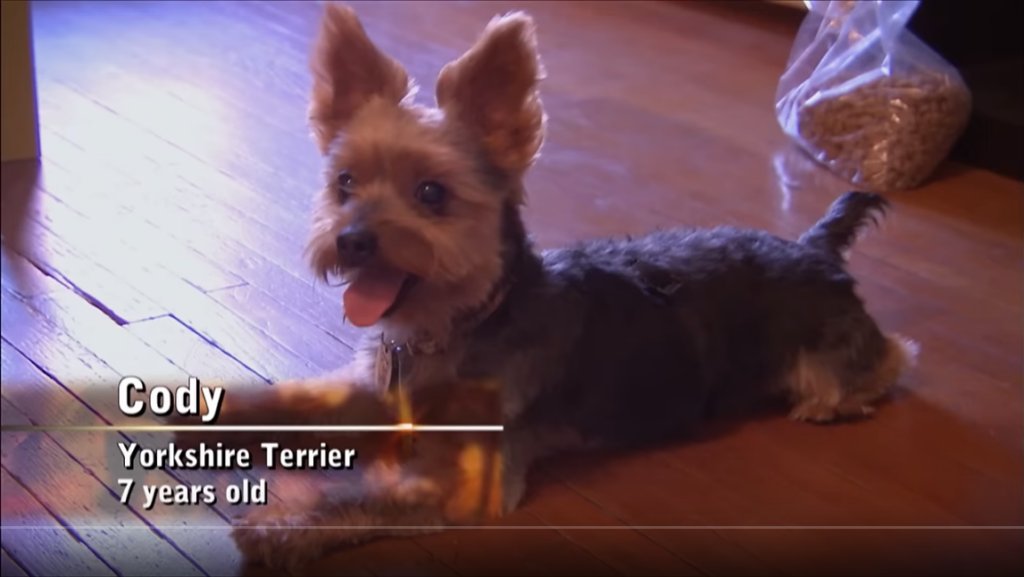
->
[775,0,971,192]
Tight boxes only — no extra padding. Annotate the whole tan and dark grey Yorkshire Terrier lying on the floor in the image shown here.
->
[172,4,915,568]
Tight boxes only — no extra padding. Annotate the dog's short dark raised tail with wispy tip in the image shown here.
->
[798,192,890,259]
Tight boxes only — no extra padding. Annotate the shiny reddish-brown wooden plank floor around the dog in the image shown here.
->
[0,1,1024,576]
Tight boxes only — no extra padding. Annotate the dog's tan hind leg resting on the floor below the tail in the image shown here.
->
[786,314,918,422]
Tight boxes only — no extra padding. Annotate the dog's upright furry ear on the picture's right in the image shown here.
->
[437,12,545,175]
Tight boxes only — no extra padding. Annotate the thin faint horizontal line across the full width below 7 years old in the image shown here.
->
[0,525,1024,531]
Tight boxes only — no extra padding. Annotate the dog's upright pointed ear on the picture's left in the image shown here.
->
[309,2,413,154]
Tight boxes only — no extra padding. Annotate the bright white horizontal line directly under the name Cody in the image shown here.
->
[2,423,505,432]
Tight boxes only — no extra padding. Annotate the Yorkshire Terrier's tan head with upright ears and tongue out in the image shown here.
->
[307,3,545,340]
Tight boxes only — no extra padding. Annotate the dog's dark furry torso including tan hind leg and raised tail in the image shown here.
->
[475,193,911,446]
